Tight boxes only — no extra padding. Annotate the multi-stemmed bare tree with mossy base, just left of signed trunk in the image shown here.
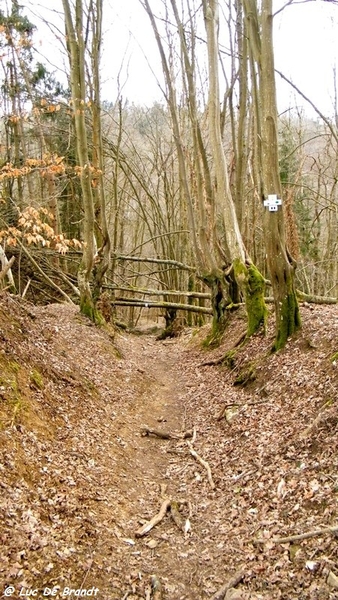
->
[142,0,266,341]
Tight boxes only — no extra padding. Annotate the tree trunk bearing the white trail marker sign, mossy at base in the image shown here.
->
[244,0,301,350]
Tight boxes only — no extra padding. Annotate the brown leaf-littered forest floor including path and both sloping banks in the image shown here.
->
[0,294,338,600]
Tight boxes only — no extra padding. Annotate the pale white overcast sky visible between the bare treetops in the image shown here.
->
[20,0,338,116]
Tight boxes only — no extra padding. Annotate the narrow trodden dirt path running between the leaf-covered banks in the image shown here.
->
[104,337,198,599]
